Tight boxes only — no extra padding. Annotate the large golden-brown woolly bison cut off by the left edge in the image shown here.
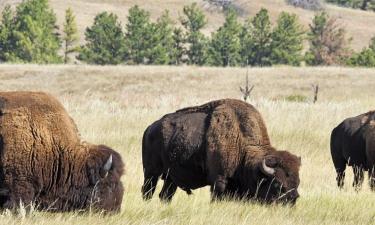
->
[0,92,124,212]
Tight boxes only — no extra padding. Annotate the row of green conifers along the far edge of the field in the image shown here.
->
[0,0,375,66]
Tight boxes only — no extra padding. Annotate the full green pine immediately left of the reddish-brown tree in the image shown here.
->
[270,12,304,66]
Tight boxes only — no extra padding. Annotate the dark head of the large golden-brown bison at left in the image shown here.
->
[86,145,124,211]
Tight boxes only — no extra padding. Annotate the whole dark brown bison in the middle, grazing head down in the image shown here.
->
[142,99,301,203]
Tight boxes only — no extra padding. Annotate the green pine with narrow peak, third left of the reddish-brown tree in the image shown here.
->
[209,10,241,66]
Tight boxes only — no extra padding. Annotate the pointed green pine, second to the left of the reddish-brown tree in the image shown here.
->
[240,8,271,66]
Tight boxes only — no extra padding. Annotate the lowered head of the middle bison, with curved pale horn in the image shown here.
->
[256,151,301,204]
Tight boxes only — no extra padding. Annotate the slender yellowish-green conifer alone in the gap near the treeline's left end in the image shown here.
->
[63,8,79,63]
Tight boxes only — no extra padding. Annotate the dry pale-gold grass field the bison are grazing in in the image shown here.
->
[0,65,375,225]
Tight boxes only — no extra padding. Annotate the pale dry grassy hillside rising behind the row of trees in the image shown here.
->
[0,0,375,50]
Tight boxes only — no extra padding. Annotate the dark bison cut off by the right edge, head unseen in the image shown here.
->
[331,111,375,190]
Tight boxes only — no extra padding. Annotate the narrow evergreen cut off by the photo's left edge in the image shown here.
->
[0,5,15,62]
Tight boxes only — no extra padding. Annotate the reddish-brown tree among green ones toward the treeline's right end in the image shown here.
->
[306,12,350,65]
